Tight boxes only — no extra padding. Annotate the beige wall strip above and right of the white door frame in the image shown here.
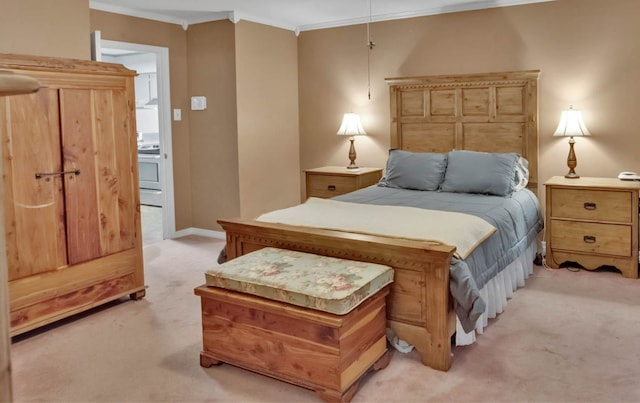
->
[90,10,193,230]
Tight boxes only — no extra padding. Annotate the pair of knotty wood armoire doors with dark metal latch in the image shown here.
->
[0,89,136,281]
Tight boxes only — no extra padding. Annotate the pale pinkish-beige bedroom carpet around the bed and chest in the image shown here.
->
[7,236,640,402]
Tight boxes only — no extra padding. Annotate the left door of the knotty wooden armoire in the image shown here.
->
[0,89,67,281]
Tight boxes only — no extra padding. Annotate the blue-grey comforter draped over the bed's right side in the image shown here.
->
[334,186,543,332]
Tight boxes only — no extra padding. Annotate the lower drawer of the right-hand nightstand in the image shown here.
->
[551,220,631,256]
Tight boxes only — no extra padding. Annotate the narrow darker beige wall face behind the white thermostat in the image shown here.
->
[187,20,240,229]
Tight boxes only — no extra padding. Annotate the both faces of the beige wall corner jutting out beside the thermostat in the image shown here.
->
[187,20,300,230]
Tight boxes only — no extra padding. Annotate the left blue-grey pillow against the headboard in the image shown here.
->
[380,149,447,190]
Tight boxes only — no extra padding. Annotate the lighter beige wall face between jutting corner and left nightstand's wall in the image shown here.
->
[236,21,300,217]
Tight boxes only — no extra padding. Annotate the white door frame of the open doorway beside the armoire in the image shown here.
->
[96,39,176,239]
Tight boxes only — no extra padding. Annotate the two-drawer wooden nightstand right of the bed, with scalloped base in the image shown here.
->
[544,176,640,278]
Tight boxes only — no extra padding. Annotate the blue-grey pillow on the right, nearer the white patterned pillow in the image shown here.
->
[441,151,520,196]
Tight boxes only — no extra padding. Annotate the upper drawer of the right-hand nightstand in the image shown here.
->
[551,188,633,223]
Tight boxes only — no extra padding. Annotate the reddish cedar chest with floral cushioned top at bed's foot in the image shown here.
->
[195,248,393,401]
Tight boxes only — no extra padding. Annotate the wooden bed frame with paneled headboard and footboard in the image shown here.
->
[218,70,539,371]
